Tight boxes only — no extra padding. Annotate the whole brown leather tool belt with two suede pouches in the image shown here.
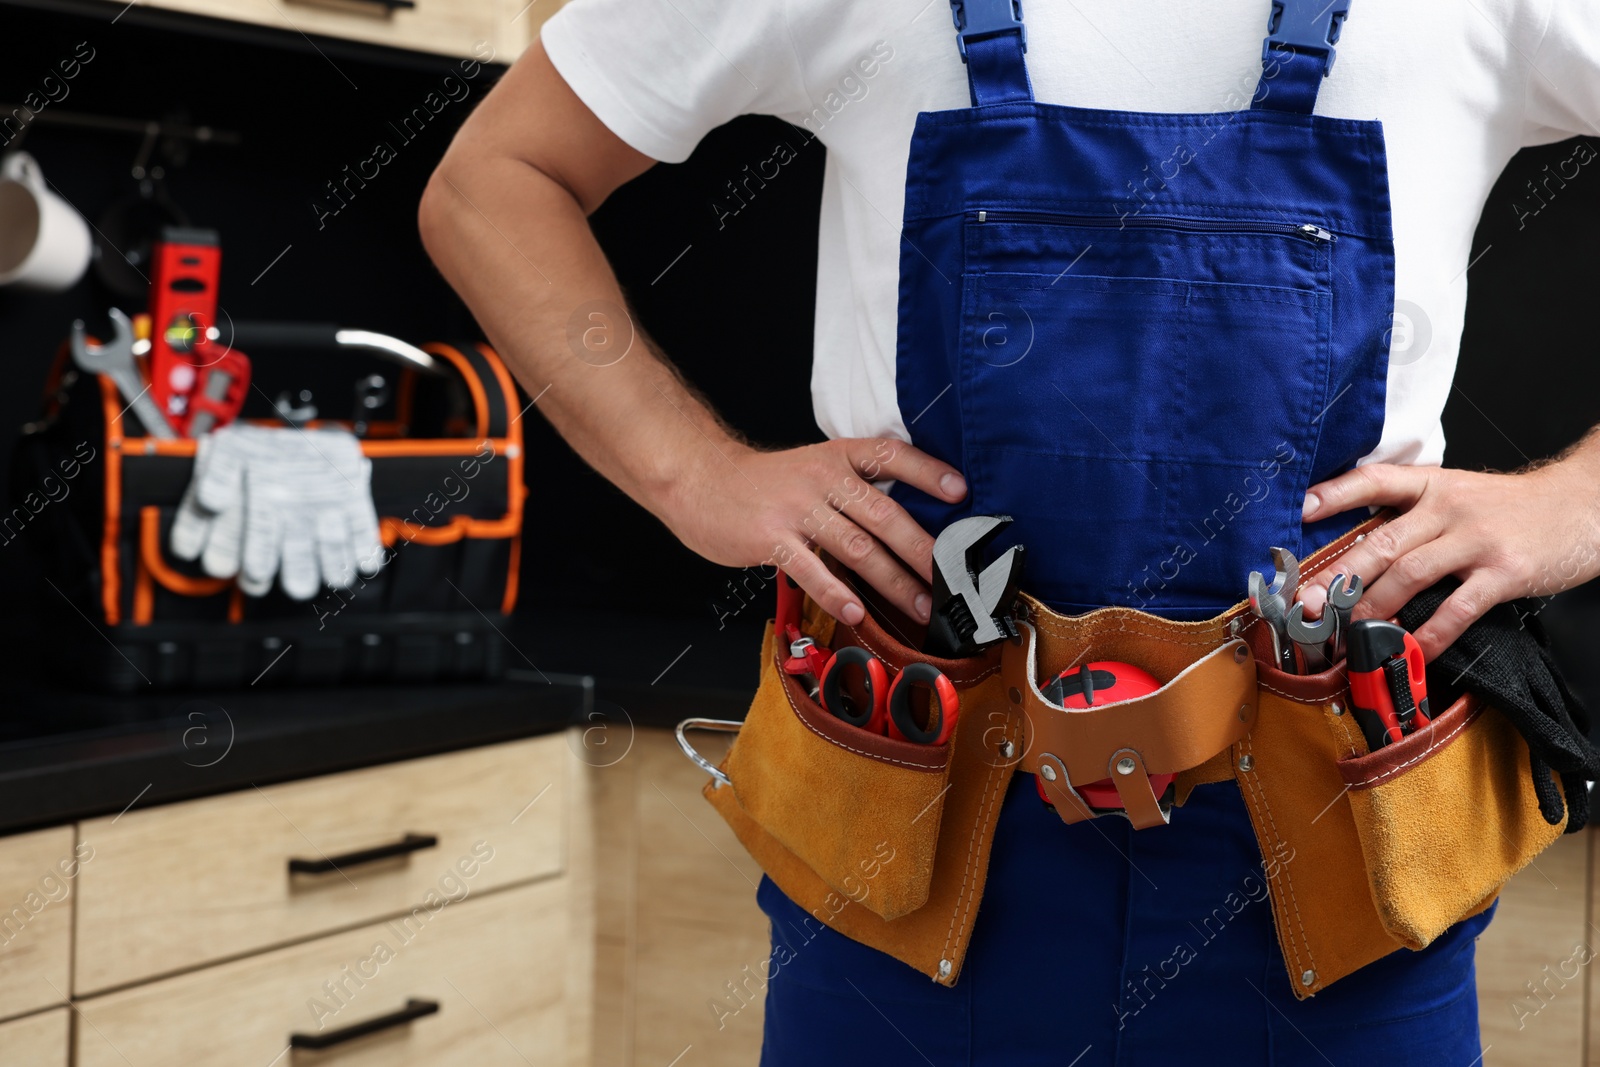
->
[678,515,1563,998]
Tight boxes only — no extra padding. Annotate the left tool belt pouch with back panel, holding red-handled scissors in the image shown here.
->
[702,585,1022,985]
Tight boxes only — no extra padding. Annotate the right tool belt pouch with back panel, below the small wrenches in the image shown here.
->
[1230,514,1562,998]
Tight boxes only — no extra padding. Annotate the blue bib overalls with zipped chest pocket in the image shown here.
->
[758,0,1488,1067]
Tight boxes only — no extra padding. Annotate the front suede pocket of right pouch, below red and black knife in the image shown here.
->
[1339,694,1562,949]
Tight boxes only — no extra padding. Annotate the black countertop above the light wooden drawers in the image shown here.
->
[0,611,763,833]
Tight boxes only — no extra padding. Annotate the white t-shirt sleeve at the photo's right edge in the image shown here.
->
[1523,0,1600,144]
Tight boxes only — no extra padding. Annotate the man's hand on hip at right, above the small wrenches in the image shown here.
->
[1301,435,1600,659]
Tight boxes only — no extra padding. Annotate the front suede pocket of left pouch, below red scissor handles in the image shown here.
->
[722,625,954,920]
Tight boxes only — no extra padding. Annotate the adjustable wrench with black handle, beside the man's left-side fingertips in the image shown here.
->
[922,515,1022,659]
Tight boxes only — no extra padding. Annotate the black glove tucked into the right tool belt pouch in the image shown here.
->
[1398,577,1600,833]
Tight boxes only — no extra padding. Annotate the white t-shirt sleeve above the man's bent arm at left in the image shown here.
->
[539,0,810,163]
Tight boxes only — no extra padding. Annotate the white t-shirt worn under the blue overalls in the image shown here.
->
[542,0,1600,464]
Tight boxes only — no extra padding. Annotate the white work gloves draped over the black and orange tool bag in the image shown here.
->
[171,424,384,600]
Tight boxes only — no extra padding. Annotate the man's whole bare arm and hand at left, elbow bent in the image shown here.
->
[419,42,966,624]
